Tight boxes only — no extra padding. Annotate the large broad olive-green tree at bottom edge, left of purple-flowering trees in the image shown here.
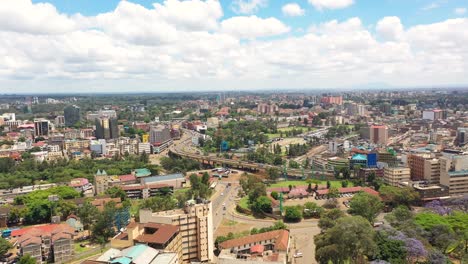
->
[315,216,377,263]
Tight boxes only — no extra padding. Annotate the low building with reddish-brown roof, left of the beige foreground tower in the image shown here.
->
[110,222,182,263]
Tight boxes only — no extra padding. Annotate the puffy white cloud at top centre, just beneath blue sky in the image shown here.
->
[221,16,290,39]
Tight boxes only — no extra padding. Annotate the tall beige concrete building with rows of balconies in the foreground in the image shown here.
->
[140,200,214,263]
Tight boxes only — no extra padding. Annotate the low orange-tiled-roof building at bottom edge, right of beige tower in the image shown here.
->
[218,230,289,264]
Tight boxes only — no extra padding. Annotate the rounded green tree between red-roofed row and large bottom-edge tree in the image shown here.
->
[349,192,383,223]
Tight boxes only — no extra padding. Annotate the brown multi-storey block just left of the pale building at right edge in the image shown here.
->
[408,153,440,184]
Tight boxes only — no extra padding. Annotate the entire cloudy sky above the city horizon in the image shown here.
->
[0,0,468,93]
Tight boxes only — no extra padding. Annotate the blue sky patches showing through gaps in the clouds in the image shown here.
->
[33,0,468,28]
